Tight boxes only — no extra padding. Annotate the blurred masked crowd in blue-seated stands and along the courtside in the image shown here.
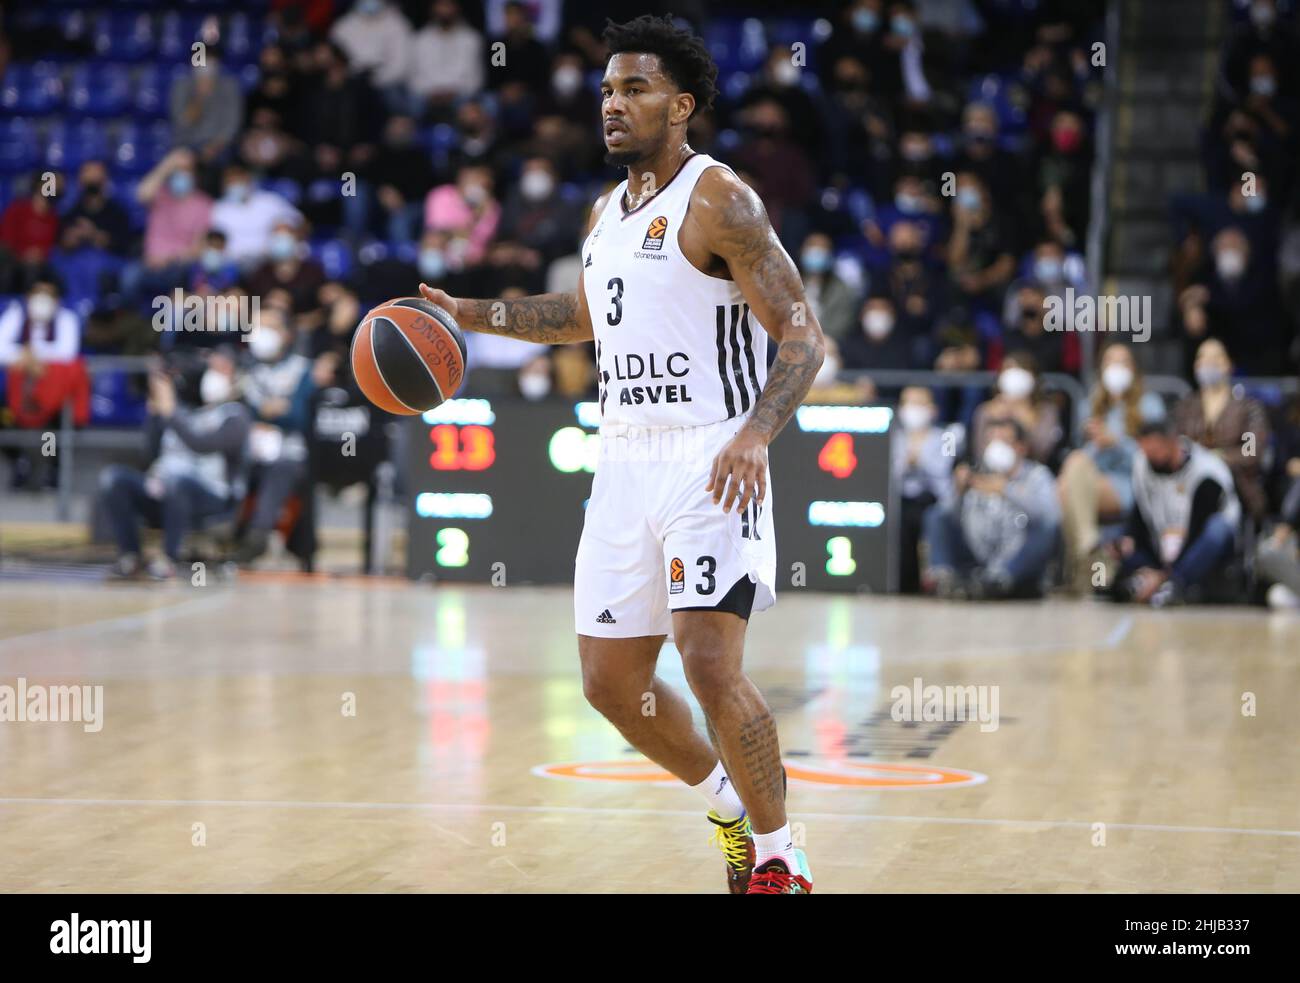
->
[0,0,1300,605]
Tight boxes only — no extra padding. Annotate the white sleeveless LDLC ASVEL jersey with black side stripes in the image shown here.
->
[582,153,767,426]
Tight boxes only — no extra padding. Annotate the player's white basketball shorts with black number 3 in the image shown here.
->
[573,416,776,638]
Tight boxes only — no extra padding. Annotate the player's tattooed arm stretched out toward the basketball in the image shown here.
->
[420,195,608,345]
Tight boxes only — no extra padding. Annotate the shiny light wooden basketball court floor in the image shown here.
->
[0,577,1300,893]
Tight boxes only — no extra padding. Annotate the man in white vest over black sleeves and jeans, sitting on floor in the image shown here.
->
[1112,421,1242,607]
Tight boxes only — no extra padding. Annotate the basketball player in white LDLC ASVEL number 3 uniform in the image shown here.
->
[420,16,823,895]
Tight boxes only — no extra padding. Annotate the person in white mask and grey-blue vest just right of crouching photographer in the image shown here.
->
[235,309,316,564]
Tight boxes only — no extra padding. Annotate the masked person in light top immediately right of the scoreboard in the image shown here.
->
[891,386,957,594]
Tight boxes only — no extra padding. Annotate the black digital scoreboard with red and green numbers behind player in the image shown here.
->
[406,398,897,593]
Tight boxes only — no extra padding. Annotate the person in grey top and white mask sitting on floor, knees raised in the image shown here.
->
[923,419,1061,599]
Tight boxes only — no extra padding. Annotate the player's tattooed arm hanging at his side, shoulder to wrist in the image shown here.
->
[692,168,826,441]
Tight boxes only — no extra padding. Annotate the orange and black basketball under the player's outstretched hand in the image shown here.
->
[352,296,465,416]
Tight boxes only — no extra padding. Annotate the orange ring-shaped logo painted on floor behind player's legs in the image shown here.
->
[533,758,988,789]
